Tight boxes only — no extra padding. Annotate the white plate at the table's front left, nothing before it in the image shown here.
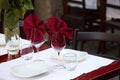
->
[11,61,50,77]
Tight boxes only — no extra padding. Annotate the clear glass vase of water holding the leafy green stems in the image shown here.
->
[5,26,20,60]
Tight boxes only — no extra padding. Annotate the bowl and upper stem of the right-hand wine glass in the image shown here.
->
[51,32,66,56]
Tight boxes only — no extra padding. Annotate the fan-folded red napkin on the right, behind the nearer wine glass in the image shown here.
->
[46,17,73,40]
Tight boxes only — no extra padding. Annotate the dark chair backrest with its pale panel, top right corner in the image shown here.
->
[102,0,120,30]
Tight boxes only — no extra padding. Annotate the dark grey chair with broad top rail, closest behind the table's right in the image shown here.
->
[74,31,120,57]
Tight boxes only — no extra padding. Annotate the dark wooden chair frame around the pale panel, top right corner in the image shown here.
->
[103,0,120,32]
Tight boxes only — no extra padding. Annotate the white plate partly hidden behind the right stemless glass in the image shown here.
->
[51,49,88,61]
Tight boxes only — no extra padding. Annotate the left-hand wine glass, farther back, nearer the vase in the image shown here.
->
[30,28,45,52]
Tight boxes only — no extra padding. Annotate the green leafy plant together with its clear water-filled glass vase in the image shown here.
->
[0,0,34,58]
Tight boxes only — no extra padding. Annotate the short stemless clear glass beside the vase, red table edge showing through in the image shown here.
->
[20,44,34,60]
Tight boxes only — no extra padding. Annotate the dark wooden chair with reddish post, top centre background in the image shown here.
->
[61,0,101,31]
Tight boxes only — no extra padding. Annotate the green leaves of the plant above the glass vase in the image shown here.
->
[0,0,33,29]
